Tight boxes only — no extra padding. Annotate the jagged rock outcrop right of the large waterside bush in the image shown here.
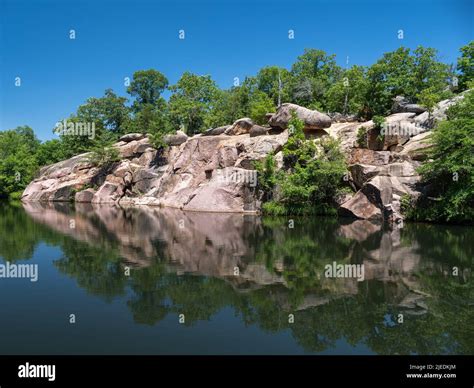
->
[334,92,462,223]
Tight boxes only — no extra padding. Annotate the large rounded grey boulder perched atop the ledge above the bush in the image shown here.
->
[268,103,331,131]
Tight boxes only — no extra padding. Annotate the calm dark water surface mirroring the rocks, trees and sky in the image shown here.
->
[0,204,474,354]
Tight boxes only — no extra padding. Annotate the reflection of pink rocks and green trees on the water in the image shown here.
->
[0,203,474,354]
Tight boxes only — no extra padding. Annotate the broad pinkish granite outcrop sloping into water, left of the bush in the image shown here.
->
[22,126,288,212]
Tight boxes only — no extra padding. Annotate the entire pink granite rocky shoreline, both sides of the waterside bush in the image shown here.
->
[22,96,462,222]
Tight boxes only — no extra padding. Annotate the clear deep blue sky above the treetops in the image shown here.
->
[0,0,474,140]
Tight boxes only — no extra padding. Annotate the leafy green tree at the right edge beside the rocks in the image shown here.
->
[405,91,474,223]
